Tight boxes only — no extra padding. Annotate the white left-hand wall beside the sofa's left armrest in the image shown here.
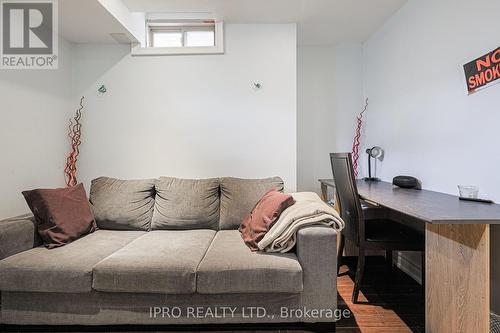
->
[0,39,73,219]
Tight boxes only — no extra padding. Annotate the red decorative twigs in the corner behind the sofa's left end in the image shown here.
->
[64,96,85,187]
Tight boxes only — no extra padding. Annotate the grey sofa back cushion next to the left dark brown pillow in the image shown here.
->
[90,177,155,230]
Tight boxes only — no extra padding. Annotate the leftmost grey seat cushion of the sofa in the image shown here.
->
[0,230,145,293]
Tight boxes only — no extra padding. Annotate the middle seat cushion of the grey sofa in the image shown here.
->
[93,230,215,294]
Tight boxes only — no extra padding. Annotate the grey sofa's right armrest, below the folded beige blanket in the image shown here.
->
[297,226,337,321]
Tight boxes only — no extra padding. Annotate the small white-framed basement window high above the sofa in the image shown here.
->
[133,19,224,55]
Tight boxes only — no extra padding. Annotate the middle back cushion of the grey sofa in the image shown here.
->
[151,177,219,230]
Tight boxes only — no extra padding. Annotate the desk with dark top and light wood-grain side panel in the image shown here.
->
[357,180,500,333]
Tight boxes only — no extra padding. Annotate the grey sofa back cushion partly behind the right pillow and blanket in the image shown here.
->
[219,177,283,230]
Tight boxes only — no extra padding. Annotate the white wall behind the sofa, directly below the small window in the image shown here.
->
[73,24,296,191]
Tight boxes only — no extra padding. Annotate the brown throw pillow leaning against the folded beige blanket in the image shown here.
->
[240,189,295,251]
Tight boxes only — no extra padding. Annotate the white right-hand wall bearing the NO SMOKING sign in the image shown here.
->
[364,0,500,306]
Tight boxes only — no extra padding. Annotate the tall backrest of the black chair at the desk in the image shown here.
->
[330,153,364,246]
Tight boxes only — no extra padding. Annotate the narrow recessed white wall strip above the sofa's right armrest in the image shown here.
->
[297,46,335,192]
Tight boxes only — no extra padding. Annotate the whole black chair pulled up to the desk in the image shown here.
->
[330,153,425,303]
